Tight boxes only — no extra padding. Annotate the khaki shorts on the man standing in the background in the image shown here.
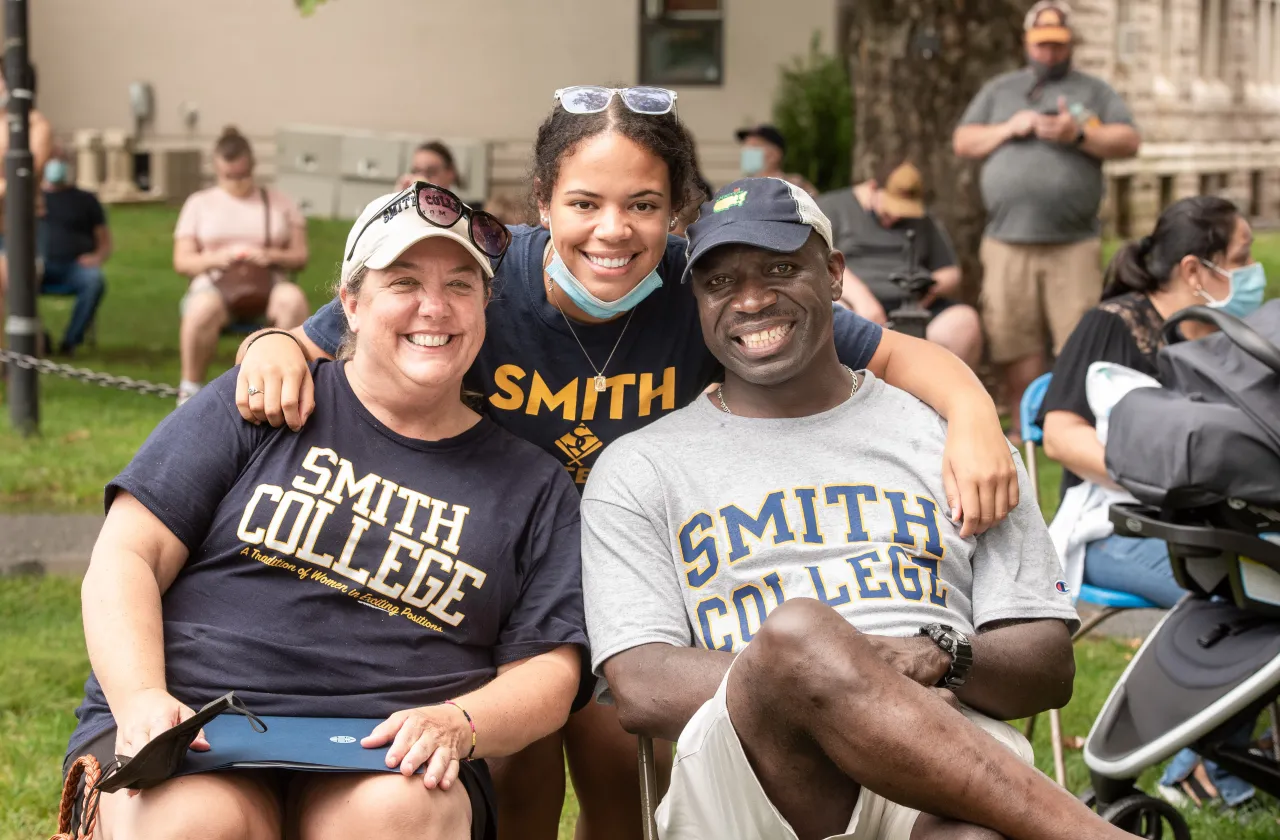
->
[980,237,1102,365]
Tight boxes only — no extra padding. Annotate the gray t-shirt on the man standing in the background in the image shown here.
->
[960,68,1133,245]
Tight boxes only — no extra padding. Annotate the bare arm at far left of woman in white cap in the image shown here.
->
[81,490,207,755]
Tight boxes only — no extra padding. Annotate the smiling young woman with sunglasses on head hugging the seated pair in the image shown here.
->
[237,87,1018,840]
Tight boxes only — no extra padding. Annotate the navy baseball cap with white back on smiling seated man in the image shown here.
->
[680,178,835,283]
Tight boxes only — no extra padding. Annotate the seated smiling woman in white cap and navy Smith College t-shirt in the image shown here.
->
[60,190,586,840]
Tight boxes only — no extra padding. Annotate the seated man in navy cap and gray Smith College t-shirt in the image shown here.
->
[582,178,1126,840]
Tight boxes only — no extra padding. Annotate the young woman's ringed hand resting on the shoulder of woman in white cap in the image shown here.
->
[236,327,333,432]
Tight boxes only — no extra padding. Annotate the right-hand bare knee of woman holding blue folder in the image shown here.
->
[298,773,471,840]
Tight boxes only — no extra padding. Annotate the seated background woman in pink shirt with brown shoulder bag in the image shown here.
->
[173,125,311,406]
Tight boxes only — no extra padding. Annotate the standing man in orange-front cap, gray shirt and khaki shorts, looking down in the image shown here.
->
[954,0,1140,430]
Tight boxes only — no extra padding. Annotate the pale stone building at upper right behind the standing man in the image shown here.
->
[1074,0,1280,236]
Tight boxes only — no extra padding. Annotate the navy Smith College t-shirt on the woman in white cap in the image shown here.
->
[69,362,586,753]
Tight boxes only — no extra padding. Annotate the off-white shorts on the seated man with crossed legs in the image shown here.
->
[657,674,1034,840]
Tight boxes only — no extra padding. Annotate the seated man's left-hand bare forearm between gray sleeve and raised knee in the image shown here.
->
[604,642,733,741]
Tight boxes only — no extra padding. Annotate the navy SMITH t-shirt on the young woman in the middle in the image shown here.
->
[305,227,881,492]
